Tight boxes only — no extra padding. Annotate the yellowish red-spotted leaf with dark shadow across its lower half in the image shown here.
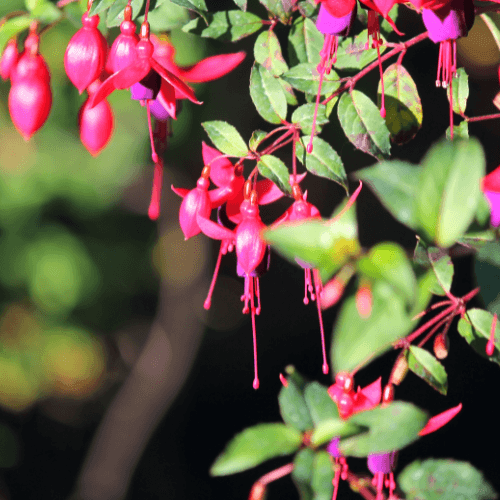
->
[378,63,423,144]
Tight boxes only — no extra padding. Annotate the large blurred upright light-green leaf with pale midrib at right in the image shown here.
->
[416,139,485,247]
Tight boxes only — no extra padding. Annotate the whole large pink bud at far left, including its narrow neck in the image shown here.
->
[9,31,52,141]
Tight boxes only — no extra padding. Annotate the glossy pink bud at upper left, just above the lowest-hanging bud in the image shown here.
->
[64,13,108,94]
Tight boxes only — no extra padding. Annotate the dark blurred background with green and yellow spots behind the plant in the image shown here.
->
[0,0,500,500]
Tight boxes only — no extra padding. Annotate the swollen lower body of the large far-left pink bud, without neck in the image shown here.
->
[9,78,52,141]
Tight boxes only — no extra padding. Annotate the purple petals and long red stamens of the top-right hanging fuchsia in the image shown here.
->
[422,0,474,139]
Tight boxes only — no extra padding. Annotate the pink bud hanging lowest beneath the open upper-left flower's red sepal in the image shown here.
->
[78,80,114,156]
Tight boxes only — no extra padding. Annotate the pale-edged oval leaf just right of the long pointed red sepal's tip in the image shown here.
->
[250,64,287,124]
